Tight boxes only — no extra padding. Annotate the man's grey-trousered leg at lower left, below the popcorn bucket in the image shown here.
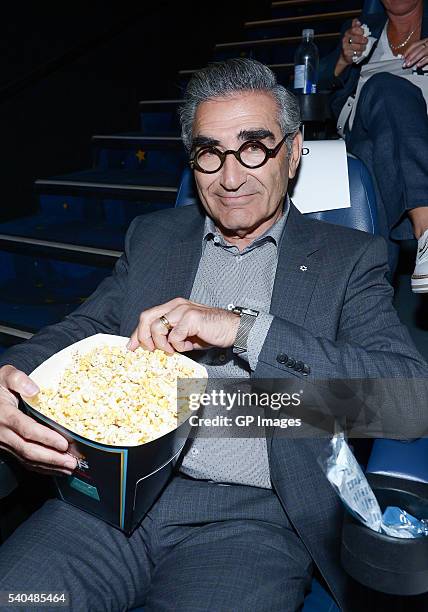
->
[0,499,151,612]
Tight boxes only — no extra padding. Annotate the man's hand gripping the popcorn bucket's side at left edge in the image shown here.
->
[0,365,77,476]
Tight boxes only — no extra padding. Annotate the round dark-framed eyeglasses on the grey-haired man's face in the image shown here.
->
[189,134,290,174]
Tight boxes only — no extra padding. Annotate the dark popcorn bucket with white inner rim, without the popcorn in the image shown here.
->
[23,334,208,534]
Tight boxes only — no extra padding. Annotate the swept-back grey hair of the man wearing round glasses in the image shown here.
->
[180,58,300,153]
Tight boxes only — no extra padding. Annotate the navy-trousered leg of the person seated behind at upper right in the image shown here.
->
[346,73,428,240]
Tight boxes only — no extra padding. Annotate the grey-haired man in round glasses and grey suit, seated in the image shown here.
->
[0,59,427,612]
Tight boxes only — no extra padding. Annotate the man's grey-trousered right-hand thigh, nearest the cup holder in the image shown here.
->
[143,478,312,612]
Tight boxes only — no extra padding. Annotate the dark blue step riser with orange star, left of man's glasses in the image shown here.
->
[92,132,186,174]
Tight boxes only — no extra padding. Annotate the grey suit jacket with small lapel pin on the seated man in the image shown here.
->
[0,206,428,610]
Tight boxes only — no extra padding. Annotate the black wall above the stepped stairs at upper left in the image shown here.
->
[0,0,251,220]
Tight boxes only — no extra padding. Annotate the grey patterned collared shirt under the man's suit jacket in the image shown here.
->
[180,198,289,488]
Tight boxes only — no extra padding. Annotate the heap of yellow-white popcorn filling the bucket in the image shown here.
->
[33,346,196,446]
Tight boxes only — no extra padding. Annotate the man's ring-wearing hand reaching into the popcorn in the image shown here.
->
[128,298,240,353]
